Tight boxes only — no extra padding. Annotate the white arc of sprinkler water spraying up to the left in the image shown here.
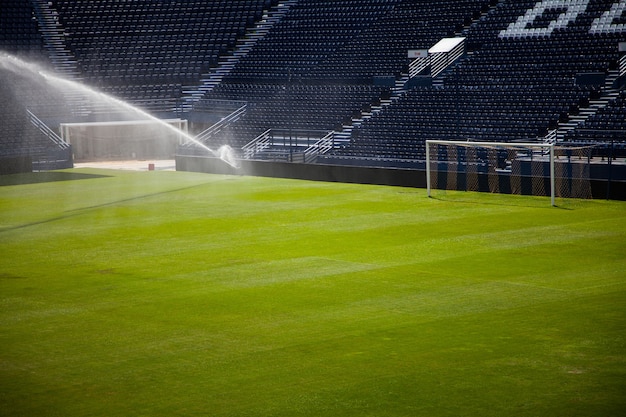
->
[0,53,239,168]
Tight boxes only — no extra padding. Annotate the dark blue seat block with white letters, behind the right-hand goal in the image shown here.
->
[326,1,624,166]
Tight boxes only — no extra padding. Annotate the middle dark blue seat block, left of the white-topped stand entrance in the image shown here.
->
[195,1,498,153]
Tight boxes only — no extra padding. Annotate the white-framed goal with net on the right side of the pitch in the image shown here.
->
[426,140,591,205]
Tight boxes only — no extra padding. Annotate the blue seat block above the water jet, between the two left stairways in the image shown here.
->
[53,0,271,111]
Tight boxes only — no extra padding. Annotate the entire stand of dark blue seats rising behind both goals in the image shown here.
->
[0,0,626,173]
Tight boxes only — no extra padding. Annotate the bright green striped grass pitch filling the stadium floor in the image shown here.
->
[0,169,626,417]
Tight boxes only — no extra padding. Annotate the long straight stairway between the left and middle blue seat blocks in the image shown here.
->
[180,0,298,113]
